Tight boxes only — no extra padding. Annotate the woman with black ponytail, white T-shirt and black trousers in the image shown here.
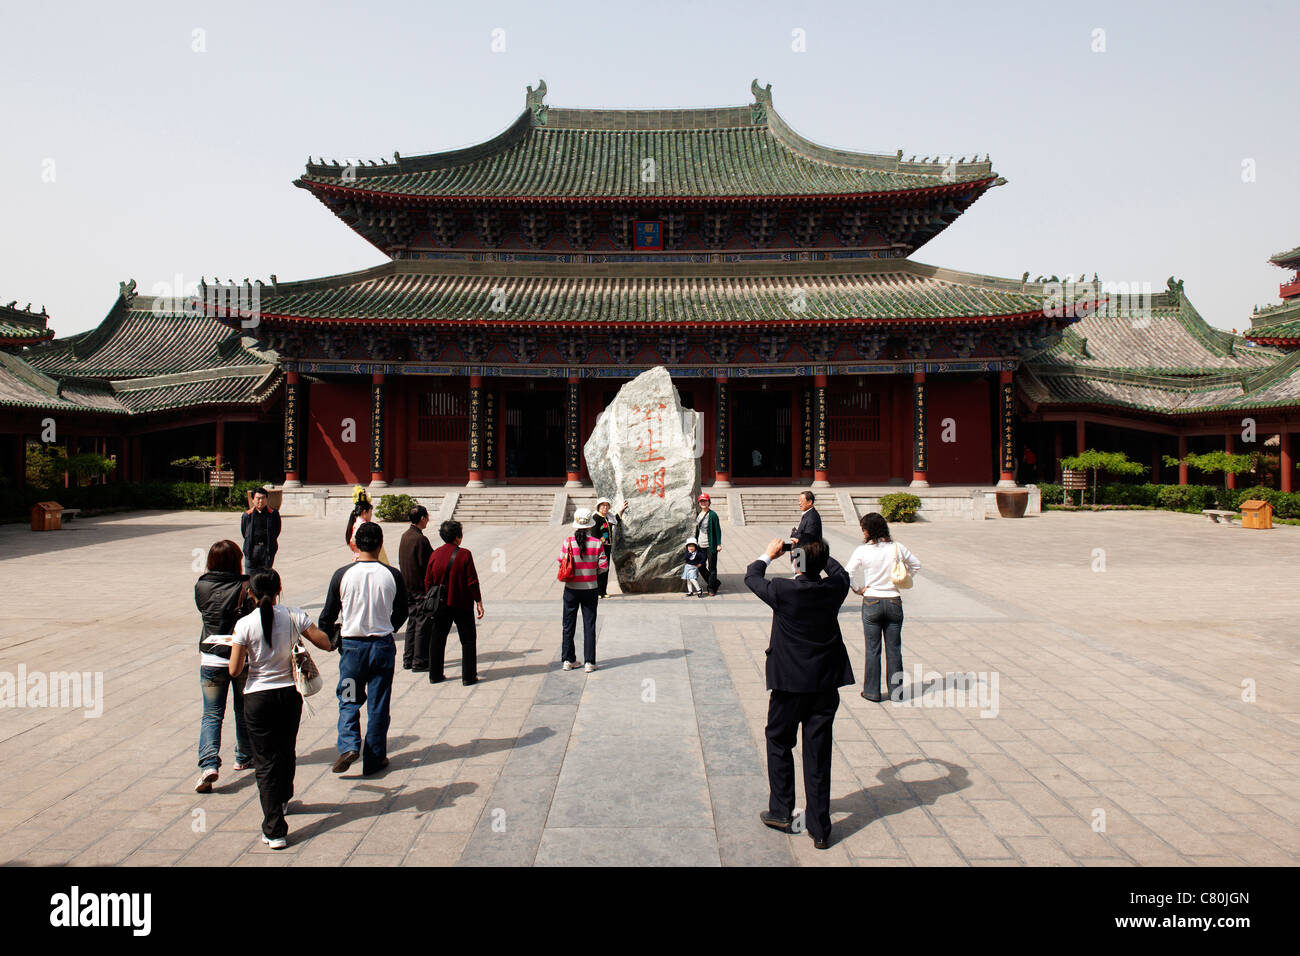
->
[230,571,330,849]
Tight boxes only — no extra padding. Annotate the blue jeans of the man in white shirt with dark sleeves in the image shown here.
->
[337,635,398,774]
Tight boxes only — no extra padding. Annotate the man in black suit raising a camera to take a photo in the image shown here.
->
[745,537,853,849]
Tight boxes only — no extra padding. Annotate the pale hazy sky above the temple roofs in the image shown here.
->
[0,0,1300,336]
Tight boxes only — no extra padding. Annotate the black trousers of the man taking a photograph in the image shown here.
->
[767,689,840,840]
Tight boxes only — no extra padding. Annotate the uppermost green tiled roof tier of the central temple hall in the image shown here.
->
[295,81,1005,202]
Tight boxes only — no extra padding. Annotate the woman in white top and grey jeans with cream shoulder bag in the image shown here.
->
[845,511,920,704]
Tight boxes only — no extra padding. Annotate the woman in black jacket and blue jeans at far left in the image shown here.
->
[194,541,252,793]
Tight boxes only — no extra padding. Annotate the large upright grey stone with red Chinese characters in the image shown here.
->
[582,365,702,593]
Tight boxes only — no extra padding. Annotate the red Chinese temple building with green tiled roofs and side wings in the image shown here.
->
[0,82,1300,488]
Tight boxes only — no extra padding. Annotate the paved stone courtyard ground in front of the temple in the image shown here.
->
[0,509,1300,866]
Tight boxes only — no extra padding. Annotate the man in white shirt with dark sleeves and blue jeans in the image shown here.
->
[320,522,407,775]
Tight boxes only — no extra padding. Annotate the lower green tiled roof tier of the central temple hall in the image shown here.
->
[253,260,1043,324]
